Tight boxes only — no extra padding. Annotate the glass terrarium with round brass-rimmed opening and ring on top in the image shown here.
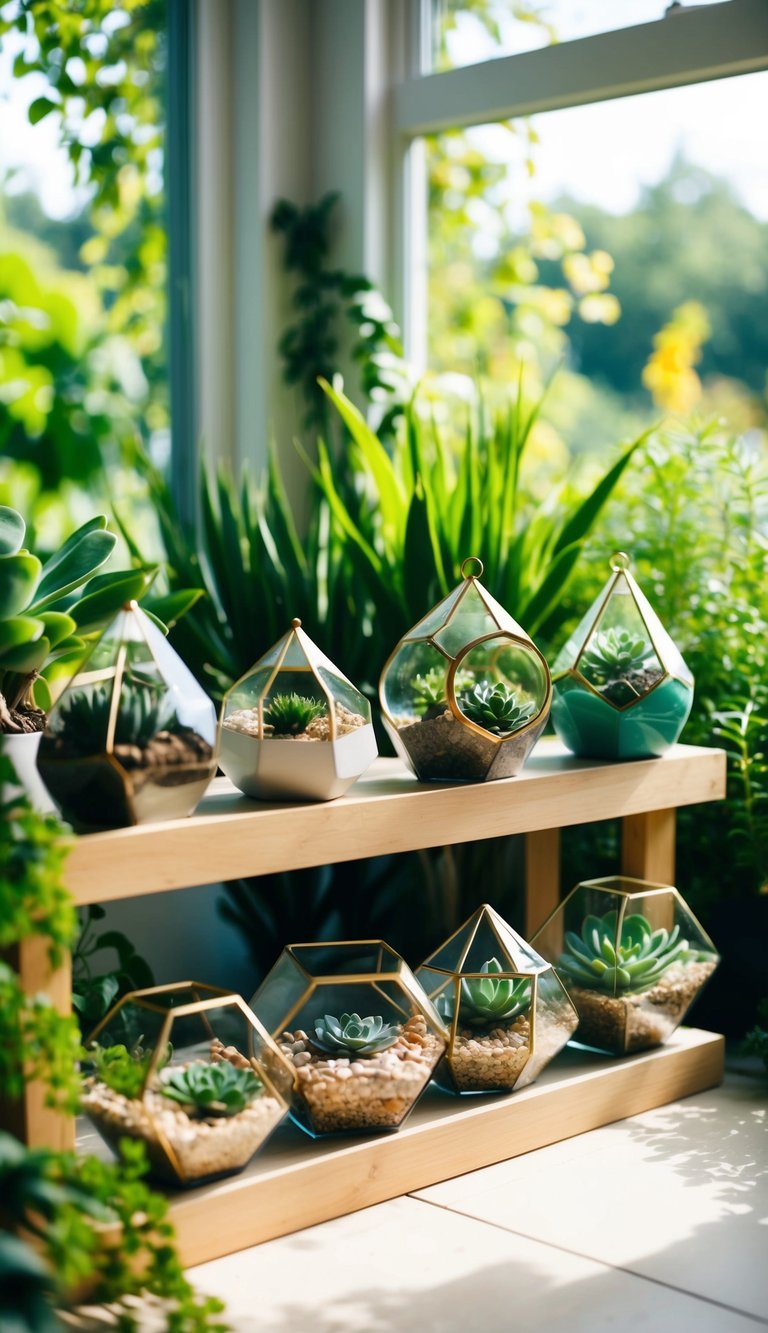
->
[379,556,552,782]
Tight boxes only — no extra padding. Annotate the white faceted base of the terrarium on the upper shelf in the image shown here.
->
[219,722,377,801]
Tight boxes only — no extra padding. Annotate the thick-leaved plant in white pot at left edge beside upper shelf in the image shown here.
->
[0,505,149,810]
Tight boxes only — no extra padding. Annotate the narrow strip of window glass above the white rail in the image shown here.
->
[432,0,721,71]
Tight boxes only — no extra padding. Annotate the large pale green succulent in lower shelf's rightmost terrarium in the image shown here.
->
[557,910,699,994]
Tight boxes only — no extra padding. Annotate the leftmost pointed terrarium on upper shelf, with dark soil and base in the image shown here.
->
[37,601,216,829]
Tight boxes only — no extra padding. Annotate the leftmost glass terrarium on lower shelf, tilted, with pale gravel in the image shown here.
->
[83,981,293,1185]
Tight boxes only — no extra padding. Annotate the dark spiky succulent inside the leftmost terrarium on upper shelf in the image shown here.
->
[52,678,176,754]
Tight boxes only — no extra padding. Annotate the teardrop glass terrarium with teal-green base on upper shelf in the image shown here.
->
[552,551,693,758]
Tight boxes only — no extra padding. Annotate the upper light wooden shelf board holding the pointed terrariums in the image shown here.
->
[67,737,725,905]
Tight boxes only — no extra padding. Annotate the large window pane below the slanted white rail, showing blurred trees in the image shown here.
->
[427,73,768,457]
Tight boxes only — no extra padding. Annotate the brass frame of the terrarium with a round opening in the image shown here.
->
[379,556,552,751]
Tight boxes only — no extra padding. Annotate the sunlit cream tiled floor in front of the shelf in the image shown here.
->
[191,1074,768,1333]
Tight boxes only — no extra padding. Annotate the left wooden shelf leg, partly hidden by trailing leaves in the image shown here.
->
[0,936,75,1150]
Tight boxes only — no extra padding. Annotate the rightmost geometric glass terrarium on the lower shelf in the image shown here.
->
[533,876,720,1056]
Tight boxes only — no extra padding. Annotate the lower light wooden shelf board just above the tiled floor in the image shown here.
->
[79,1028,724,1266]
